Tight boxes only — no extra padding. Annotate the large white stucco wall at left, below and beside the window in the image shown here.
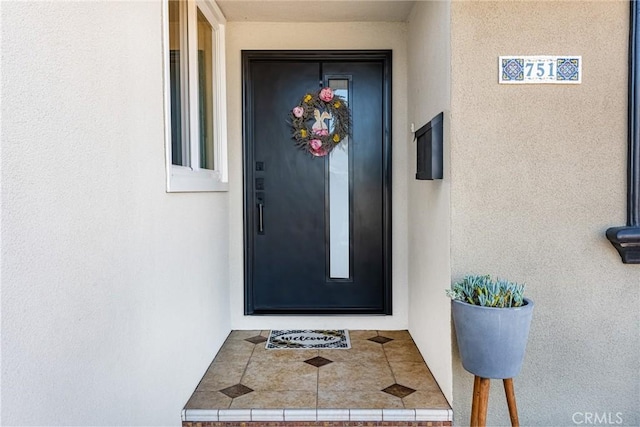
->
[0,1,229,426]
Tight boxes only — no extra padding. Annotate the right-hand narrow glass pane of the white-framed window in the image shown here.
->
[198,9,214,169]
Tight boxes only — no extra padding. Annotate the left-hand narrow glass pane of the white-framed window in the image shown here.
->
[169,0,190,166]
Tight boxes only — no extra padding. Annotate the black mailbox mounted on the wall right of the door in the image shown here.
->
[415,113,444,180]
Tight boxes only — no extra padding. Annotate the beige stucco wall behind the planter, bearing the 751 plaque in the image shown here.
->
[451,2,640,426]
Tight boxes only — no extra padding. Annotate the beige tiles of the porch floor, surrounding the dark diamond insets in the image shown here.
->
[185,330,450,416]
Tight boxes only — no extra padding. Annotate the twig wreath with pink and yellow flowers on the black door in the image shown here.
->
[291,87,351,157]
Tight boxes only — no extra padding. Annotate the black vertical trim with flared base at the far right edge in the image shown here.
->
[606,0,640,264]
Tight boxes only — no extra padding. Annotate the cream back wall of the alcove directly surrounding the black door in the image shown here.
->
[227,22,408,329]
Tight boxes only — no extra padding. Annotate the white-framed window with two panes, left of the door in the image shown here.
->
[163,0,228,192]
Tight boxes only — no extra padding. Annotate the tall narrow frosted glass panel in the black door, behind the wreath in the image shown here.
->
[328,79,351,279]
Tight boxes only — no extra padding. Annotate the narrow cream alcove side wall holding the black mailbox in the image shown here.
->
[406,1,453,402]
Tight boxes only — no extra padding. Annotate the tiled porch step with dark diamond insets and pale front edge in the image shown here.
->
[182,330,452,426]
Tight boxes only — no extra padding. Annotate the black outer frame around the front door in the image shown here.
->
[242,50,392,315]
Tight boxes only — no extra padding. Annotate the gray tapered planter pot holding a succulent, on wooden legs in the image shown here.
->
[451,298,533,378]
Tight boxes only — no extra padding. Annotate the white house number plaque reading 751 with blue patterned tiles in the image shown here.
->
[498,56,582,84]
